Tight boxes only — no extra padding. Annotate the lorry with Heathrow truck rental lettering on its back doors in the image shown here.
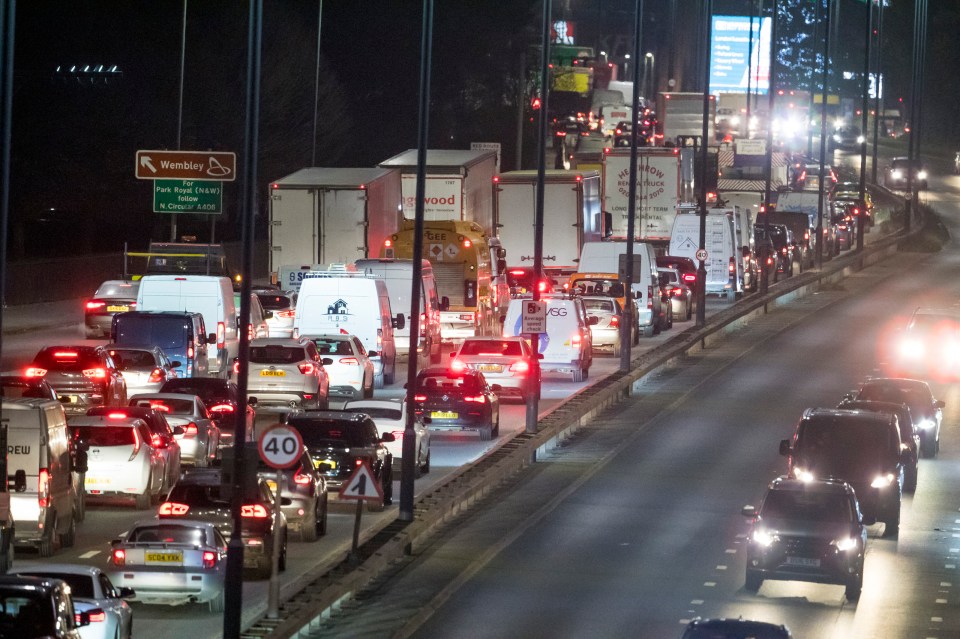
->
[603,147,684,242]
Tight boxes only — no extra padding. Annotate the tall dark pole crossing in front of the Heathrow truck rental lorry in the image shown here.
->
[620,0,646,373]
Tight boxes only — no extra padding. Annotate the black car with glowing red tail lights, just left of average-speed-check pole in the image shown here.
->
[414,368,500,441]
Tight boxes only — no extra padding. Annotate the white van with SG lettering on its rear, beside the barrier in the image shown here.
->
[503,294,597,382]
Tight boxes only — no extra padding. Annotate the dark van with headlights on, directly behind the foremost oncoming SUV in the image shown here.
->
[780,408,910,537]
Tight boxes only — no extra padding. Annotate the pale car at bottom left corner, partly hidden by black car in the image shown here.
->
[15,564,135,639]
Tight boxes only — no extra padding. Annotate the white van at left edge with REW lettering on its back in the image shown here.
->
[2,399,85,557]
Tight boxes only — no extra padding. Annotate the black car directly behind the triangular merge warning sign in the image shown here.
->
[287,410,394,510]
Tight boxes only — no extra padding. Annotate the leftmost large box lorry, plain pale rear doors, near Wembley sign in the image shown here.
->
[269,167,401,290]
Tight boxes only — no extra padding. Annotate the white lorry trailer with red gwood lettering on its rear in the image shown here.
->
[379,149,497,237]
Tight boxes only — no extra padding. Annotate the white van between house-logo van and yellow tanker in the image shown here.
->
[354,258,441,368]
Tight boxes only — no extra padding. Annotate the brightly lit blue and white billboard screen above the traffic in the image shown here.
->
[710,16,770,94]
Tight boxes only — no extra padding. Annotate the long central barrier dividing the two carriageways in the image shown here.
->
[242,221,907,639]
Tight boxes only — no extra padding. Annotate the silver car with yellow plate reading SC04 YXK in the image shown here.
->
[107,519,227,612]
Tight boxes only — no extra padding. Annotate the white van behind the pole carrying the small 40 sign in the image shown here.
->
[670,209,743,300]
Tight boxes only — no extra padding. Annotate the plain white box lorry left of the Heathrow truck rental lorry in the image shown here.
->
[494,170,601,274]
